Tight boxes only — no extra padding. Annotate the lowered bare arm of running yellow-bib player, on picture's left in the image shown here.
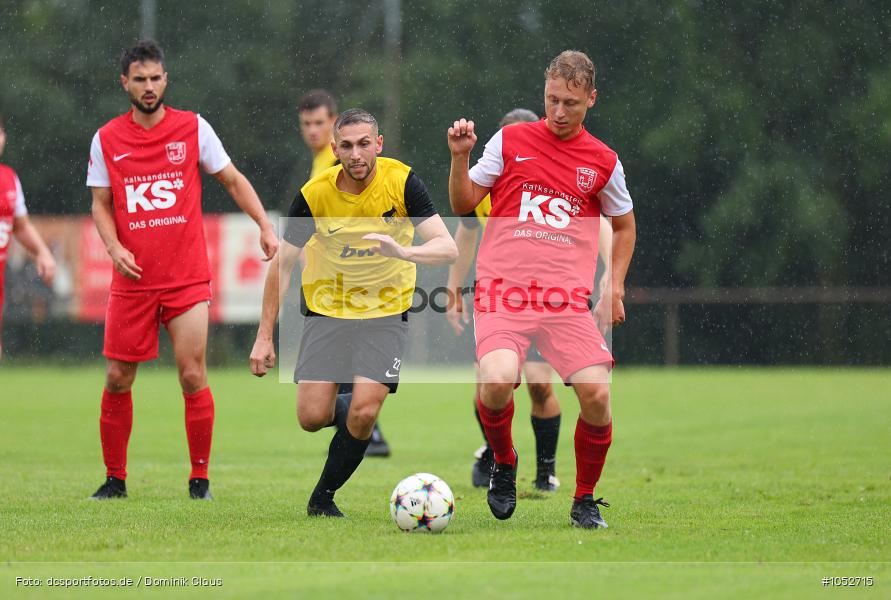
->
[250,242,301,377]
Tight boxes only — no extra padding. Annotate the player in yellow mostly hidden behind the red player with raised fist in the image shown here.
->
[446,108,611,492]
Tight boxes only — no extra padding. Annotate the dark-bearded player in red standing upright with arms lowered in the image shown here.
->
[87,40,278,500]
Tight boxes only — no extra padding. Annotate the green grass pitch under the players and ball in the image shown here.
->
[0,366,891,599]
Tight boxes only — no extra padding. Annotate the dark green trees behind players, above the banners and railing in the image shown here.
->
[0,0,891,360]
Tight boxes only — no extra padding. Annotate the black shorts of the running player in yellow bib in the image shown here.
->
[294,313,408,394]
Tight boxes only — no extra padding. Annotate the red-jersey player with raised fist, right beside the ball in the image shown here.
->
[448,51,635,529]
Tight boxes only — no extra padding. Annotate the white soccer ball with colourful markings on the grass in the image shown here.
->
[390,473,455,533]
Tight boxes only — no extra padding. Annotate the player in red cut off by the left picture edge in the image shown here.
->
[0,116,56,358]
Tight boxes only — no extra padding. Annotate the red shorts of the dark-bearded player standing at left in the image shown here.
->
[102,281,211,362]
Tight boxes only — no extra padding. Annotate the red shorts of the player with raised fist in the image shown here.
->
[473,310,616,385]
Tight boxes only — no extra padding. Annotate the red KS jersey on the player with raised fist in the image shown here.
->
[470,120,632,311]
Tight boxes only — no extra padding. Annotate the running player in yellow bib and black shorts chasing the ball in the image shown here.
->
[250,109,458,517]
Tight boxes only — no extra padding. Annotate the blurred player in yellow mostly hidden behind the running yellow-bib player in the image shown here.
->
[297,90,390,457]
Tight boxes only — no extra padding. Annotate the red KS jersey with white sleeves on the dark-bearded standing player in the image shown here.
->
[87,107,230,291]
